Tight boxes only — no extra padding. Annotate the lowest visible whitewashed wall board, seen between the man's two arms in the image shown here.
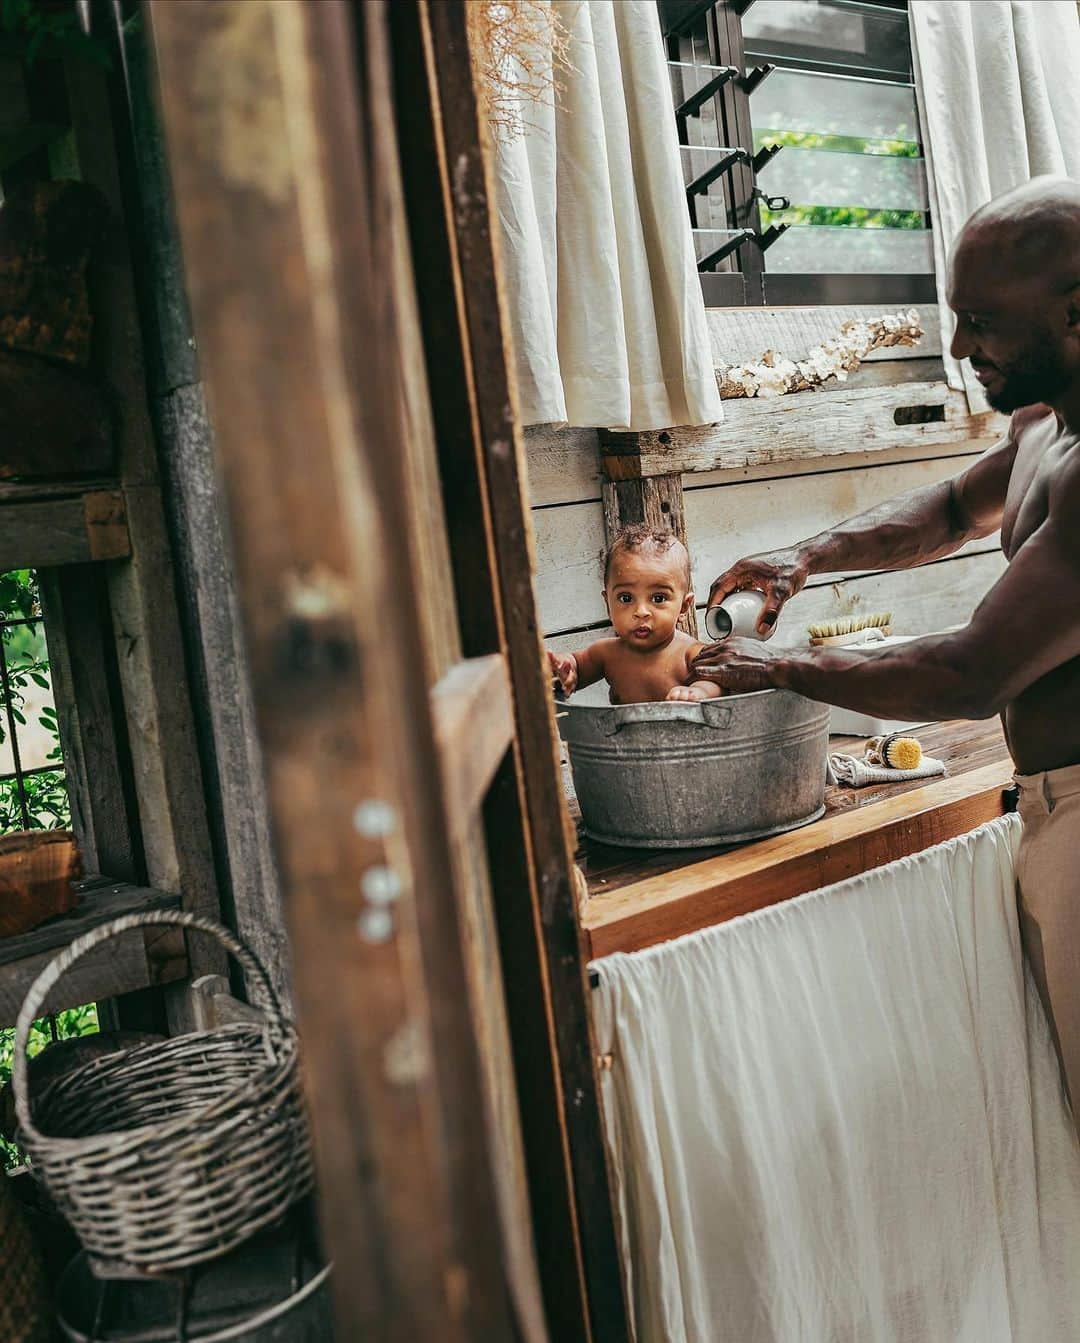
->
[544,551,1006,653]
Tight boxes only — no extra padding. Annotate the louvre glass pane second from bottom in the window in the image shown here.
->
[759,149,928,211]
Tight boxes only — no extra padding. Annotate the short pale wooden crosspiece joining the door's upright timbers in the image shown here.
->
[431,653,514,835]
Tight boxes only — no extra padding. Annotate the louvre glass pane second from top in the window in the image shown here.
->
[750,67,919,141]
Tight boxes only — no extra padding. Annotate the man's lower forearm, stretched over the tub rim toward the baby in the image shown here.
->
[774,635,998,723]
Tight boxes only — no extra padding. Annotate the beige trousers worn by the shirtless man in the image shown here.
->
[1017,764,1080,1124]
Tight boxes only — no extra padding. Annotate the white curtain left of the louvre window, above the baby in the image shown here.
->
[496,0,723,430]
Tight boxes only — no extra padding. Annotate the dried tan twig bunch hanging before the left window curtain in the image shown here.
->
[466,0,574,140]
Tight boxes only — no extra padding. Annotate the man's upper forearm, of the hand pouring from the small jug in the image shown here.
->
[794,481,969,575]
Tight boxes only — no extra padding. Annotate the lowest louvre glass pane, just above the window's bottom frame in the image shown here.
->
[766,226,934,275]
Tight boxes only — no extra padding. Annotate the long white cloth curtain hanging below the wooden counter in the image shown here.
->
[592,817,1080,1343]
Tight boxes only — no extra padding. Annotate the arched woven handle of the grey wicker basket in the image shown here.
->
[11,909,290,1138]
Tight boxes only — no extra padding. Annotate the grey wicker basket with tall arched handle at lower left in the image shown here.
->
[12,911,312,1273]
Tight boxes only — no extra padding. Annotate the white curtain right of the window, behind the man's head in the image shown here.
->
[908,0,1080,410]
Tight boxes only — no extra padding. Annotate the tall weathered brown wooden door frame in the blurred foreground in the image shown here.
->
[150,0,626,1343]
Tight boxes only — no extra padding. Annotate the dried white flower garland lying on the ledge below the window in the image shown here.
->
[716,308,923,399]
